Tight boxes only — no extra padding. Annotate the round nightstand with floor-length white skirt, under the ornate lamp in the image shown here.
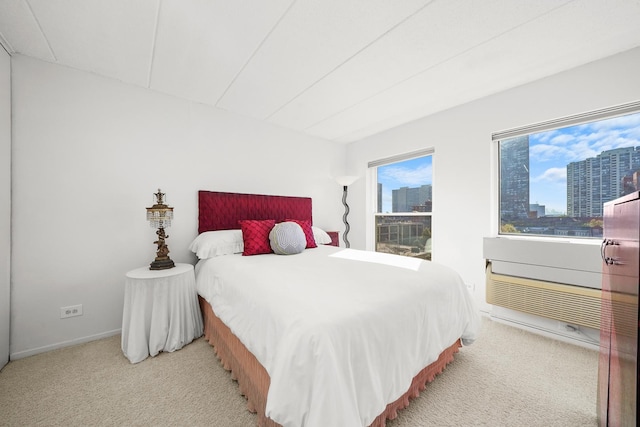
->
[122,263,202,363]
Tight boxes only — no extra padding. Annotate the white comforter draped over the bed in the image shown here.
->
[196,246,479,427]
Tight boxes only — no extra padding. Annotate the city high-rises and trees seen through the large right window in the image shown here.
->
[500,136,640,237]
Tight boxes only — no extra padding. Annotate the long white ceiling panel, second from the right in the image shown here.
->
[269,0,568,130]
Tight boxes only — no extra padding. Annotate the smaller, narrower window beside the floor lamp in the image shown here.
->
[369,149,433,260]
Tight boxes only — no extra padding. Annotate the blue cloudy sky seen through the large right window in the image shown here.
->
[529,113,640,214]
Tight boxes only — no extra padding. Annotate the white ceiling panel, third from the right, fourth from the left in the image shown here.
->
[218,0,428,119]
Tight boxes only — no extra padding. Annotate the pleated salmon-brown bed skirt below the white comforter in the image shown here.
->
[199,297,462,427]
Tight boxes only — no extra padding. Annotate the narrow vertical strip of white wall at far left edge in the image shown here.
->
[0,48,11,368]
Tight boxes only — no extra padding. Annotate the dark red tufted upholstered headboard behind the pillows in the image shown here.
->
[198,190,313,233]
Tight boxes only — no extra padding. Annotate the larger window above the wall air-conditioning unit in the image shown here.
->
[493,102,640,238]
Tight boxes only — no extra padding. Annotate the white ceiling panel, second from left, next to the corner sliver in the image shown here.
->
[29,0,159,86]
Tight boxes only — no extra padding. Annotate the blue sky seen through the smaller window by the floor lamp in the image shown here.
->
[378,156,433,212]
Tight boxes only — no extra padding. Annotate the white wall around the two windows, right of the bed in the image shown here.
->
[347,48,640,310]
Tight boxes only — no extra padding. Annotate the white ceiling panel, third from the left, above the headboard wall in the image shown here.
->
[151,0,293,105]
